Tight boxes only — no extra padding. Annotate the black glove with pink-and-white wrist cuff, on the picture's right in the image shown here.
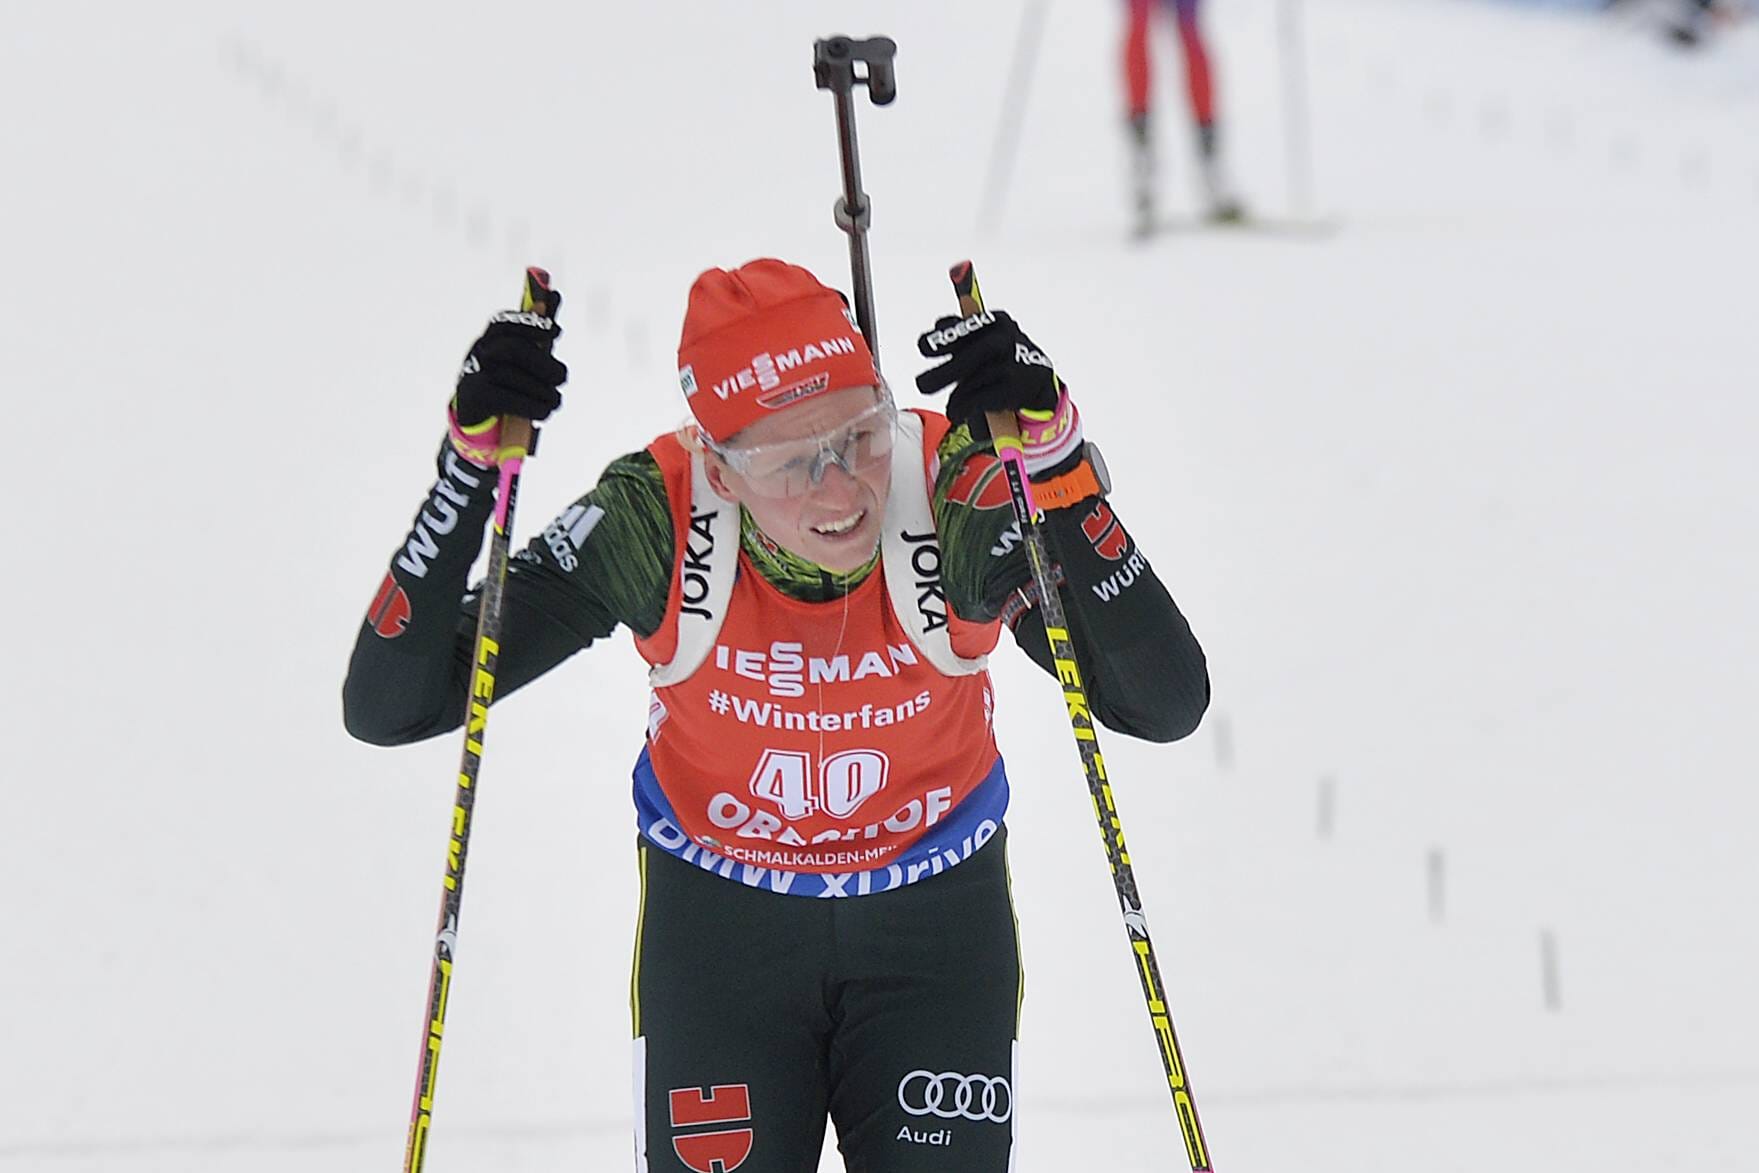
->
[916,310,1082,478]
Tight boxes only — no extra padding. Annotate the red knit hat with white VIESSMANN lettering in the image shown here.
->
[677,257,880,443]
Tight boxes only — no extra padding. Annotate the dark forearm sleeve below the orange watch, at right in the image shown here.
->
[1003,498,1210,742]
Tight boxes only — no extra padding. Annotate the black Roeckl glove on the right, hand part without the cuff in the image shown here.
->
[916,310,1062,440]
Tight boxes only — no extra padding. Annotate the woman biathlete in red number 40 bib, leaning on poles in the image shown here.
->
[343,259,1208,1173]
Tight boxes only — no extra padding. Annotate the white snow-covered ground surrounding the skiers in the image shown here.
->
[0,0,1759,1173]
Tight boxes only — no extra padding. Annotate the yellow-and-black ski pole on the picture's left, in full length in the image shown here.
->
[403,267,551,1173]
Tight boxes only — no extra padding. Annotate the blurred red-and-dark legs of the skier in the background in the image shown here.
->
[1124,0,1245,236]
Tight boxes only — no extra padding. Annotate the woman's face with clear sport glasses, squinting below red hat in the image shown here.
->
[707,387,894,573]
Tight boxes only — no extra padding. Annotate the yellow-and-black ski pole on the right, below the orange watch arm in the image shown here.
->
[948,260,1214,1173]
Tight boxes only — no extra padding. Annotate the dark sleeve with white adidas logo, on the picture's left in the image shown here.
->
[343,445,654,746]
